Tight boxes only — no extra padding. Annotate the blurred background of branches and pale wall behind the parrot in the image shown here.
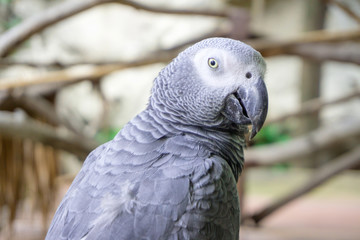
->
[0,0,360,240]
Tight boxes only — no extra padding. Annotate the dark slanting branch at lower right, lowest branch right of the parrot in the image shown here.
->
[245,147,360,223]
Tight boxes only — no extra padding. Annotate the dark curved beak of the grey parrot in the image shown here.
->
[224,78,268,139]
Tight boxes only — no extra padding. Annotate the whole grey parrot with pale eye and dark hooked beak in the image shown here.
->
[46,38,268,240]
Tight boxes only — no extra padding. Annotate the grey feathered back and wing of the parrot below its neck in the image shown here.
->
[47,108,243,239]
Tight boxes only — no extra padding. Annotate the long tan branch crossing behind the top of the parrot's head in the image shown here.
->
[0,30,360,90]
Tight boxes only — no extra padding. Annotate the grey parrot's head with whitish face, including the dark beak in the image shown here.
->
[150,38,268,138]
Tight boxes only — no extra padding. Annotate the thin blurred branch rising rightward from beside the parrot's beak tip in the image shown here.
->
[265,89,360,125]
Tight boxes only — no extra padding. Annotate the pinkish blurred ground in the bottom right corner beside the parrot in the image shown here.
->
[240,197,360,240]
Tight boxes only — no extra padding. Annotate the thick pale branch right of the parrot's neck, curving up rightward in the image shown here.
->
[245,121,360,167]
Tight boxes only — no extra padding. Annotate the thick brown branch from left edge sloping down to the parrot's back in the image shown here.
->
[0,111,98,158]
